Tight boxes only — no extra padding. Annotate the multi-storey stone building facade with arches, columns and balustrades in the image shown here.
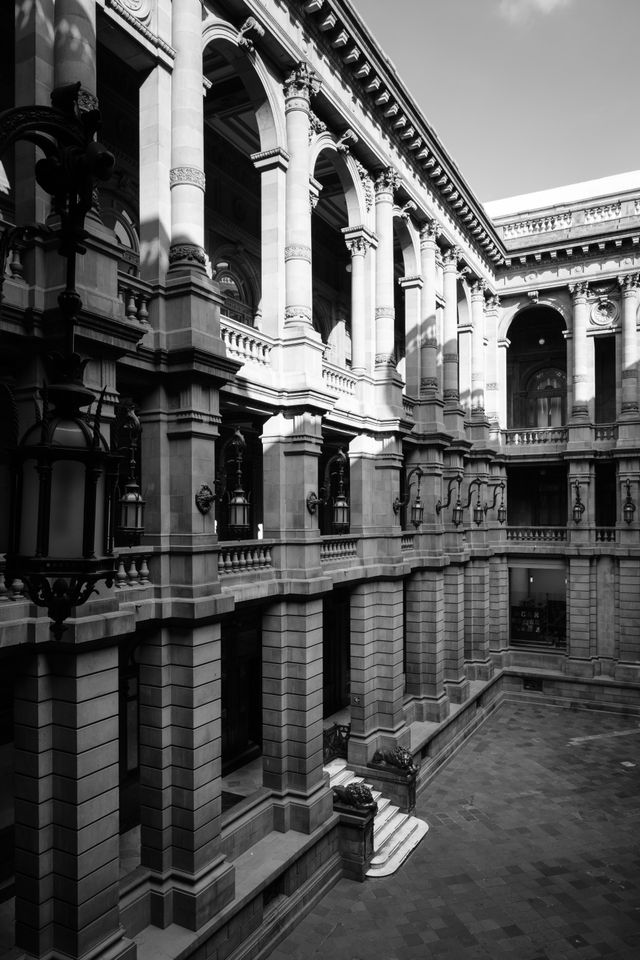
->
[0,0,640,960]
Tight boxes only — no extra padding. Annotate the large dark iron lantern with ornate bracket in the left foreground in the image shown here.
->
[0,83,119,639]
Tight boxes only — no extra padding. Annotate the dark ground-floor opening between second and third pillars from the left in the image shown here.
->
[222,609,262,775]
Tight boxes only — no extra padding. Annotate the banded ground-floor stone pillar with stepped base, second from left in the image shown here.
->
[138,623,235,930]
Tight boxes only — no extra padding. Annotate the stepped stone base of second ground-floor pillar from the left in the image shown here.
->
[151,857,236,930]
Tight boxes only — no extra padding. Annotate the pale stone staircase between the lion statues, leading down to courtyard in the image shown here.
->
[324,760,429,877]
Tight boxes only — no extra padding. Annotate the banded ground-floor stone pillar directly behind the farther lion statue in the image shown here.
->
[349,580,409,764]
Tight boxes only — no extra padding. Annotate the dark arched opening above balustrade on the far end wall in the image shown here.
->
[507,306,567,429]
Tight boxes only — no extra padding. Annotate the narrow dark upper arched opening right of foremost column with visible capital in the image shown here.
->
[311,150,351,367]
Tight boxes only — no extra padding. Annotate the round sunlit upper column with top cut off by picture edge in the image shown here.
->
[169,0,205,273]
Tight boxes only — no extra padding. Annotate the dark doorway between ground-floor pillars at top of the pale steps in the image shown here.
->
[322,590,351,717]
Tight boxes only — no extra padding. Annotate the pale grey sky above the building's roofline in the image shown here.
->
[351,0,640,201]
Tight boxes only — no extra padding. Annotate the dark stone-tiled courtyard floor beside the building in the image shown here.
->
[270,703,640,960]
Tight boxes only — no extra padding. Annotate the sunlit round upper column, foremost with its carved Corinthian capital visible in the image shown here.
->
[284,61,320,327]
